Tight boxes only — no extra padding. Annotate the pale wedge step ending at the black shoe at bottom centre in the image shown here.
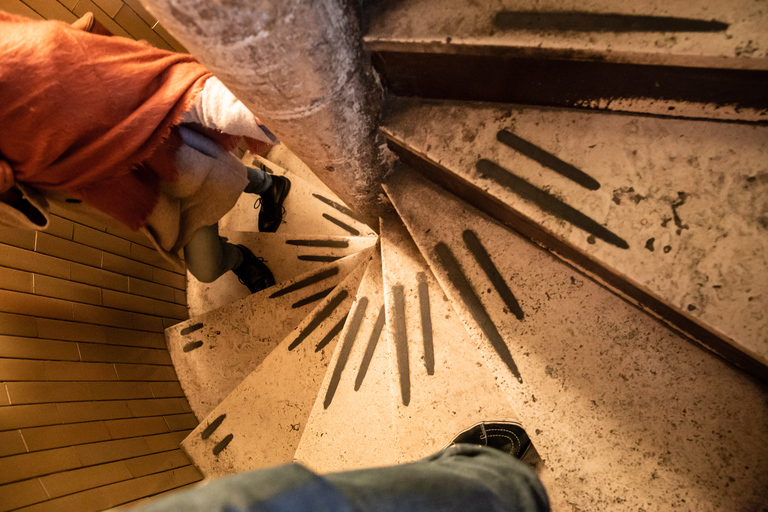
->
[381,214,517,463]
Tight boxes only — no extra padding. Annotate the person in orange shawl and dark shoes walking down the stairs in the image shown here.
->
[0,11,290,292]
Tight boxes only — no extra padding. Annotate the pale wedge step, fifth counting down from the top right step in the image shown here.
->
[295,251,397,473]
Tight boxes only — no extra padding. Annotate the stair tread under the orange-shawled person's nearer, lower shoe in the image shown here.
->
[187,234,377,316]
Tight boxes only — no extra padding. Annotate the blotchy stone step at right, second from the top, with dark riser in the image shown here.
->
[384,101,768,382]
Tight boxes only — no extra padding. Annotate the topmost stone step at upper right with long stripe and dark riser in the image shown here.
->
[365,0,768,121]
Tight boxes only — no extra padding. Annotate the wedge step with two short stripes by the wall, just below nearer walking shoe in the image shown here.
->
[165,249,372,419]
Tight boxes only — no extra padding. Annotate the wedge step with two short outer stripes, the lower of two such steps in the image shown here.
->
[181,258,370,478]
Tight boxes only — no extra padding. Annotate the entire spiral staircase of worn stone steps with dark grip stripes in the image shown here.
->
[159,0,768,510]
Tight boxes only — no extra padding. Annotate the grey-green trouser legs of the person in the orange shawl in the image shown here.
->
[184,167,272,283]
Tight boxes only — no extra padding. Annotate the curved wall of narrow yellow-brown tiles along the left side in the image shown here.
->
[0,0,202,512]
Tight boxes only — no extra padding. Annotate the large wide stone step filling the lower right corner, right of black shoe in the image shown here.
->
[385,173,768,510]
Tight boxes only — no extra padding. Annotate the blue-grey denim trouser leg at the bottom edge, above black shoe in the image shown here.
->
[135,445,550,512]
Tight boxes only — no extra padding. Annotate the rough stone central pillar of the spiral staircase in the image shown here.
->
[142,0,391,227]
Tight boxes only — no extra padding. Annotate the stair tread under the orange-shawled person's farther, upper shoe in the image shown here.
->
[219,166,376,236]
